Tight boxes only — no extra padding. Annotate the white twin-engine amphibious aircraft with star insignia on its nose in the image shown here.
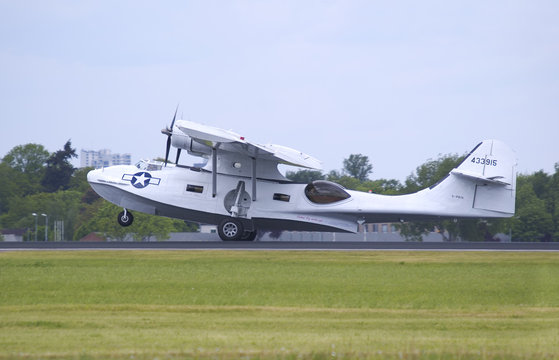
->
[87,113,516,240]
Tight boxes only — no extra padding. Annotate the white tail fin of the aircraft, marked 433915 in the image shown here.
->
[451,140,516,216]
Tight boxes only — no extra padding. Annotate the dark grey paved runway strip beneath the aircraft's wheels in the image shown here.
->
[0,241,559,251]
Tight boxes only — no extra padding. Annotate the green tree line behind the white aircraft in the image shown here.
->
[0,140,559,241]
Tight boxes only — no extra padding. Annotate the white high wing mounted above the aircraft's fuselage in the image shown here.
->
[175,120,322,170]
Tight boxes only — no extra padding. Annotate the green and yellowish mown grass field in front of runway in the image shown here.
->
[0,251,559,359]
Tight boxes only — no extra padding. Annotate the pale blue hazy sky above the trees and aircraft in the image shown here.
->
[0,0,559,181]
